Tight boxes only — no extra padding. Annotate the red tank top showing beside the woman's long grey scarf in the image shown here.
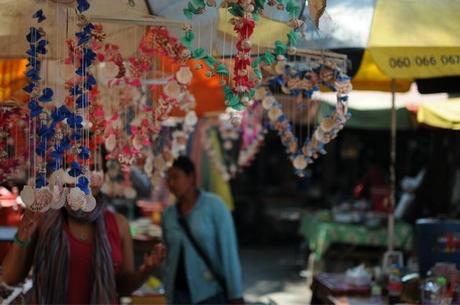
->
[65,211,123,304]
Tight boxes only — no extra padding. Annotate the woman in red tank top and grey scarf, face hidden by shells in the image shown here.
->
[2,189,164,304]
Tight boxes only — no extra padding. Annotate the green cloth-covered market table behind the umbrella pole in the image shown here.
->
[299,212,413,260]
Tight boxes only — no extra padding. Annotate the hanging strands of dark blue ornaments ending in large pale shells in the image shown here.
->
[20,0,101,212]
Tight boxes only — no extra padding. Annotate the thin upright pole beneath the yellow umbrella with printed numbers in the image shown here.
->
[388,79,397,251]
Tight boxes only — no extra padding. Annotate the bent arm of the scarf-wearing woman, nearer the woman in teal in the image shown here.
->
[116,214,164,295]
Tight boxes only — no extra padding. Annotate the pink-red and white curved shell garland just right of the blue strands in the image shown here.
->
[100,27,195,166]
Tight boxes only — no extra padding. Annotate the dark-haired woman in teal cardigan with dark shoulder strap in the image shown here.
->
[162,157,244,304]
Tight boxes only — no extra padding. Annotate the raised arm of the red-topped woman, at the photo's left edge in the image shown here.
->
[2,210,42,285]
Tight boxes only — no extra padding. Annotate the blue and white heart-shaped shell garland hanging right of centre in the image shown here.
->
[257,65,351,177]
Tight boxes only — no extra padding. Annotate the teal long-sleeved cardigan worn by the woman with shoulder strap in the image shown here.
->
[162,191,243,303]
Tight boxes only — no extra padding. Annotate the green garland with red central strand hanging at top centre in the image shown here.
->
[181,0,303,115]
